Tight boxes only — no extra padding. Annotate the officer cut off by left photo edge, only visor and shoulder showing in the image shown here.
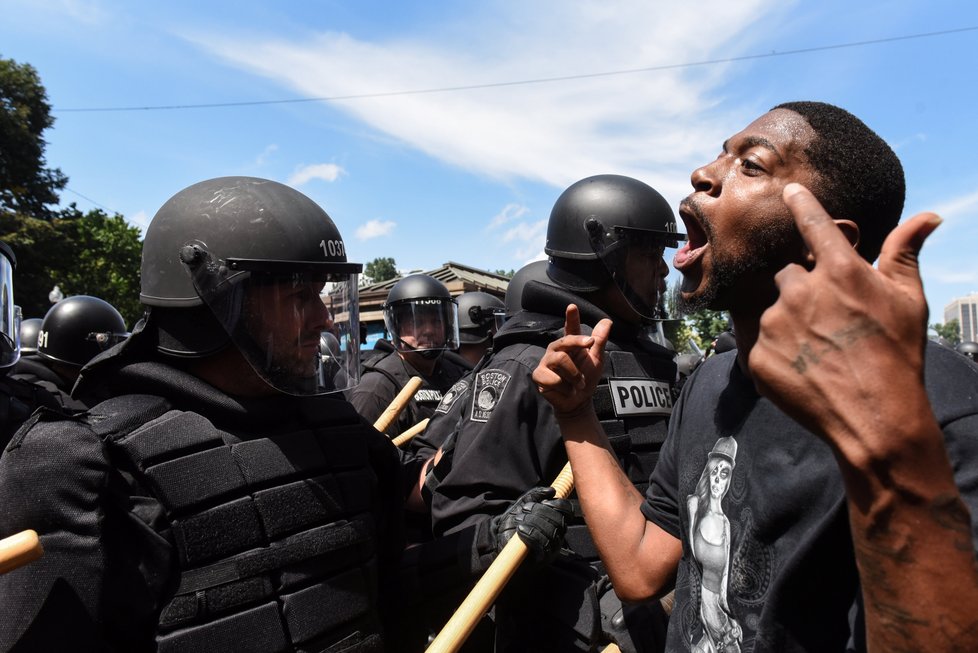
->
[0,241,61,451]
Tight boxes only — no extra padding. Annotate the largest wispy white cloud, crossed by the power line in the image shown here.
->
[183,0,785,202]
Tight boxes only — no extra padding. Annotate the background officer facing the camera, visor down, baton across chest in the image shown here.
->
[349,274,466,436]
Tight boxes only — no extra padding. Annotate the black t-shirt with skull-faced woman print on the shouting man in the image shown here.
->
[642,345,978,653]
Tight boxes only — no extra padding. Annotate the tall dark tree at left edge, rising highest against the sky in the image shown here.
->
[0,59,68,220]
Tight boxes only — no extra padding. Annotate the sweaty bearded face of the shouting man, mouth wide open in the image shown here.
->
[673,109,817,309]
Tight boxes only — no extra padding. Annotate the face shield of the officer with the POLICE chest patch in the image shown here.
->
[584,217,686,320]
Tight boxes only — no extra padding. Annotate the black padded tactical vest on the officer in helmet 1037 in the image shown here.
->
[91,395,383,653]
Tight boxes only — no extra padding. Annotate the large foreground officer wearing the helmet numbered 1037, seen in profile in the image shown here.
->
[0,177,403,652]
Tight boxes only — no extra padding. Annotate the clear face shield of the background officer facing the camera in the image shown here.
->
[384,298,459,358]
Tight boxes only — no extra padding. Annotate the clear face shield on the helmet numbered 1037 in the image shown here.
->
[181,248,360,396]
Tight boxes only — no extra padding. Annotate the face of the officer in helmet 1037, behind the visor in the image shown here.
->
[245,281,331,377]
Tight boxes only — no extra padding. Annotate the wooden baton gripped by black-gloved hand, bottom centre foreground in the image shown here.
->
[425,463,574,653]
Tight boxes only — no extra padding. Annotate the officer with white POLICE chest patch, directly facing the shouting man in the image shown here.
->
[425,175,685,651]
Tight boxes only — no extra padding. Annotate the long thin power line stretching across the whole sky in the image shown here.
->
[53,25,978,113]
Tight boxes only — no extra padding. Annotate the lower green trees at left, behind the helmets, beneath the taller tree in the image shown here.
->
[0,204,143,328]
